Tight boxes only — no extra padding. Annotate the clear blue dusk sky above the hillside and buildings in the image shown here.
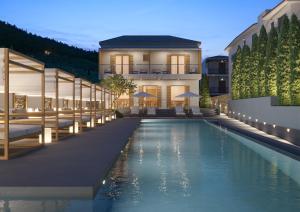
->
[0,0,280,57]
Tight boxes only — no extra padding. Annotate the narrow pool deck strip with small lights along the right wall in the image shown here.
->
[208,116,300,160]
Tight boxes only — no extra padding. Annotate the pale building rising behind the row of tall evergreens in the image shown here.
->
[225,0,300,95]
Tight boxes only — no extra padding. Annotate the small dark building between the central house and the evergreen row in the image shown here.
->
[203,56,228,96]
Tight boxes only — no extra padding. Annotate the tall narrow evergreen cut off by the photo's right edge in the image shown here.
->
[289,14,300,105]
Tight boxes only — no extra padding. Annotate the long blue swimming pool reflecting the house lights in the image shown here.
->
[0,119,300,212]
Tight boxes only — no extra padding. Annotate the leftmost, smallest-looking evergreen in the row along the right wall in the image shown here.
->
[231,46,242,99]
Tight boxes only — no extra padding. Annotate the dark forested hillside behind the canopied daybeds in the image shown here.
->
[0,21,98,82]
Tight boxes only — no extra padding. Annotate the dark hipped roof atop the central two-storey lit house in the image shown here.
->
[99,35,201,49]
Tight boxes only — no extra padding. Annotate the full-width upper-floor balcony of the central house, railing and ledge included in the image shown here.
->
[100,64,201,80]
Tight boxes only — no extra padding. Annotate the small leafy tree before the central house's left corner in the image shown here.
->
[101,74,136,102]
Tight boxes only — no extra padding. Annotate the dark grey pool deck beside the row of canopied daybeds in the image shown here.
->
[0,118,140,199]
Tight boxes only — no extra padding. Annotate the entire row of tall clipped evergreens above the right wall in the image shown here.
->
[231,15,300,105]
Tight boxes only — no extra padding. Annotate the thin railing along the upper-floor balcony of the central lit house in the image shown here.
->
[100,64,200,74]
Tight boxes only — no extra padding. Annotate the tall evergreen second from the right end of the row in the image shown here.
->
[277,15,291,105]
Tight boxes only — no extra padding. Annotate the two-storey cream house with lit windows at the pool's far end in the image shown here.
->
[99,36,202,108]
